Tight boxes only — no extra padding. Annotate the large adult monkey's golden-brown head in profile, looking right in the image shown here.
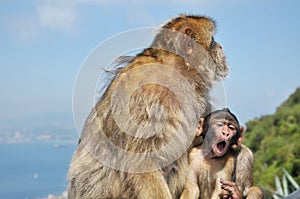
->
[151,15,229,79]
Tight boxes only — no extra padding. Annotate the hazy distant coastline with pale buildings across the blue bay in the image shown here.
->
[0,113,79,144]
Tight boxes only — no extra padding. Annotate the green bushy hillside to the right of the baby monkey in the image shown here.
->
[244,87,300,189]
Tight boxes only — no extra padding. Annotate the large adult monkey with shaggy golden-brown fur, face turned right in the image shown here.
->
[68,15,228,199]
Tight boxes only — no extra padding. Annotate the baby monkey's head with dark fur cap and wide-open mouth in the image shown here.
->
[196,108,244,157]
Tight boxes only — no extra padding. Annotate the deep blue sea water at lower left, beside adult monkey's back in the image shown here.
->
[0,142,76,199]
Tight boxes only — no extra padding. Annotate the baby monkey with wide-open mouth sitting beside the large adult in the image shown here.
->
[181,108,263,199]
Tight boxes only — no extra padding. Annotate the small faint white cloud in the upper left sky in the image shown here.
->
[36,1,78,30]
